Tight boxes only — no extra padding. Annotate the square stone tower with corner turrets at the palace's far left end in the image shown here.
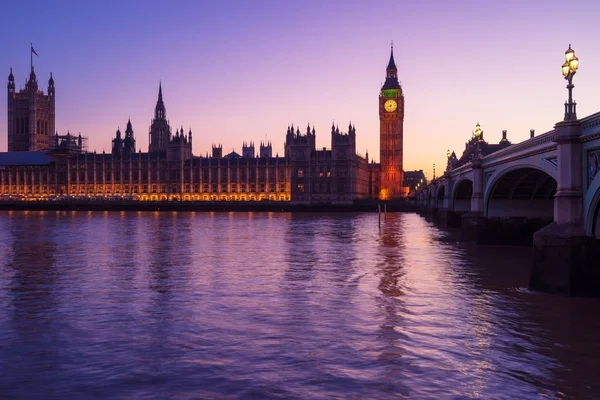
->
[7,65,55,151]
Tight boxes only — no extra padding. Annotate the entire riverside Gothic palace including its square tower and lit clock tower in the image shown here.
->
[0,49,422,204]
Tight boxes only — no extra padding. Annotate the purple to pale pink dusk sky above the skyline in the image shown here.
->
[0,0,600,178]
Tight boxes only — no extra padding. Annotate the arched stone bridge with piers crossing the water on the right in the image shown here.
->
[416,112,600,295]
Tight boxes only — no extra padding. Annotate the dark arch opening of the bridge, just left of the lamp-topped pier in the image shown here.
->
[484,165,557,222]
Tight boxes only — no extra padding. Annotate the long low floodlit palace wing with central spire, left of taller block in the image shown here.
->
[0,79,290,201]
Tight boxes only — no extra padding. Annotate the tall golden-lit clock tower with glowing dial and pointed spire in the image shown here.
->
[379,45,406,200]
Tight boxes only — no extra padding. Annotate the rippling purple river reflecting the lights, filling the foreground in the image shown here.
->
[0,211,600,399]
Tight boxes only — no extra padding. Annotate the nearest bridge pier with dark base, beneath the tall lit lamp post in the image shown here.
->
[529,121,600,296]
